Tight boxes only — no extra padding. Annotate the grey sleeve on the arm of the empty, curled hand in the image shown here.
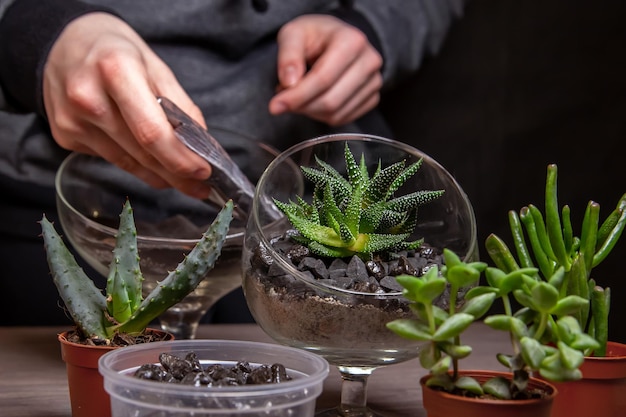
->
[347,0,467,86]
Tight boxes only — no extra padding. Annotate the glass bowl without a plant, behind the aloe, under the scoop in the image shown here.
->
[55,127,277,339]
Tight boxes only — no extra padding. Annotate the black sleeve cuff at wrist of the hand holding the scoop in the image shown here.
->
[0,0,118,115]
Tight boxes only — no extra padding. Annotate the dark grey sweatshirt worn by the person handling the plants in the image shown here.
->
[0,0,462,325]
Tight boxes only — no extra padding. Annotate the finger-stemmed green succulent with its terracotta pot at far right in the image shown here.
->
[486,164,626,417]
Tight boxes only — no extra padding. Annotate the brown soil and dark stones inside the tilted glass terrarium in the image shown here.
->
[244,231,456,352]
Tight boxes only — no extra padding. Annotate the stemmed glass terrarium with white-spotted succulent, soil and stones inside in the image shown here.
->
[243,134,477,416]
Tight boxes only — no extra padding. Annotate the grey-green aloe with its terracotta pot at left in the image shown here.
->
[40,200,233,417]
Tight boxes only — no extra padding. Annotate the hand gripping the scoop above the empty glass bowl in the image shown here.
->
[43,13,211,198]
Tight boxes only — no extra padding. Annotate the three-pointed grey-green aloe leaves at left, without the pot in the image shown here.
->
[40,199,233,341]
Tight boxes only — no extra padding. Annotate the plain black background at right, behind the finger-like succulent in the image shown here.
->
[383,0,626,342]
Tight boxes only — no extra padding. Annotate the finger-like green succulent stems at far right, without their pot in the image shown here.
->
[486,164,626,356]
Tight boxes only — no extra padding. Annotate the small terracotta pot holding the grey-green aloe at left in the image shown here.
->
[58,329,174,417]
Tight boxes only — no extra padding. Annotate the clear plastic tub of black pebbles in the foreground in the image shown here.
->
[98,340,329,417]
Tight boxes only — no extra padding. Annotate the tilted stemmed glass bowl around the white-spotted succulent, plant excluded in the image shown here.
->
[242,134,478,416]
